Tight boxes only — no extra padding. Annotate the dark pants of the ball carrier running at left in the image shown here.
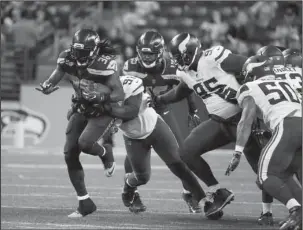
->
[64,113,112,196]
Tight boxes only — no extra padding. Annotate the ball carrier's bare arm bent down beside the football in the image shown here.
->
[107,72,125,102]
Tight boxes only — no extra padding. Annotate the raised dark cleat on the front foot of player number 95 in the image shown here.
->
[205,188,235,217]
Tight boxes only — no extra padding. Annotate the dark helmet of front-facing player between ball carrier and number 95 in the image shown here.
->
[136,31,165,68]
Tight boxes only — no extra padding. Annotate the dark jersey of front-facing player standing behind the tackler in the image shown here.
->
[123,57,179,95]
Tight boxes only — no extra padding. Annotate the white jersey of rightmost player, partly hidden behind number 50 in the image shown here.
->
[273,66,302,100]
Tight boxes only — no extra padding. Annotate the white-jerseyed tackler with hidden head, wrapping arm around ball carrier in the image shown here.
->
[102,75,211,215]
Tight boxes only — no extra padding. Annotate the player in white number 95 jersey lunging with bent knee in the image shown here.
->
[155,33,272,221]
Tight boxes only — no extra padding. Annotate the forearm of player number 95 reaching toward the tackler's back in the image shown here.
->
[157,82,193,104]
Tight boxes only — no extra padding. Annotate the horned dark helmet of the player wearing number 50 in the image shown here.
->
[241,55,275,82]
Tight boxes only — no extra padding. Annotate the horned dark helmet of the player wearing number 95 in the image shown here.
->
[168,33,202,69]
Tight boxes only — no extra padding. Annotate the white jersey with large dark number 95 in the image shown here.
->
[177,46,241,119]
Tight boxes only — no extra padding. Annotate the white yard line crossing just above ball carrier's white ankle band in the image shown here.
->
[1,183,261,194]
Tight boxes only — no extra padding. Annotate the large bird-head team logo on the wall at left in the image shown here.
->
[1,105,50,145]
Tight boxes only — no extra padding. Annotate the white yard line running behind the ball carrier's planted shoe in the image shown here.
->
[1,205,285,219]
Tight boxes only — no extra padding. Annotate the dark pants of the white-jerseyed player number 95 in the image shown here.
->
[179,119,268,190]
